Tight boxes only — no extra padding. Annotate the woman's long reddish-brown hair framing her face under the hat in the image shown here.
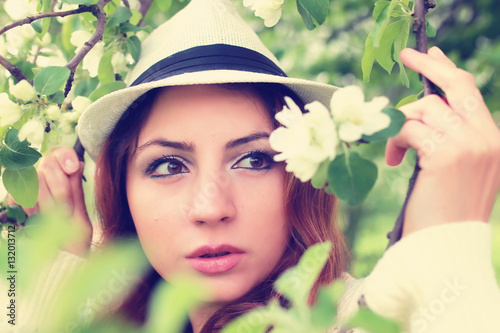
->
[95,83,347,333]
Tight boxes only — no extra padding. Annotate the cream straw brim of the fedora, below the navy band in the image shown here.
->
[77,70,338,160]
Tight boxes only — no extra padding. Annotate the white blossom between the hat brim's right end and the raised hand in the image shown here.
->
[330,86,391,142]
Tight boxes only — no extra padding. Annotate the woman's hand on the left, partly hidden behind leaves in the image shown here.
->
[11,147,92,255]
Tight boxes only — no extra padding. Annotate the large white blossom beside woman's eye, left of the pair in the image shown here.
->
[269,97,338,182]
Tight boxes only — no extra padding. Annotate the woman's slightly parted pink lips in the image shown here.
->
[186,244,245,274]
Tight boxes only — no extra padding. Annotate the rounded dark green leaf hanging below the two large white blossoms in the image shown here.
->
[328,152,377,206]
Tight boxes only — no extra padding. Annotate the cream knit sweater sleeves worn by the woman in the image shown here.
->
[0,221,500,333]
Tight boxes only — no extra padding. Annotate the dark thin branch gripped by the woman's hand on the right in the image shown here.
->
[387,0,436,248]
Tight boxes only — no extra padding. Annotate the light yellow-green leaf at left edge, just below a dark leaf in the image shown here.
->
[2,166,38,208]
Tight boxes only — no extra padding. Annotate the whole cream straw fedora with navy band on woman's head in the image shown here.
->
[77,0,337,160]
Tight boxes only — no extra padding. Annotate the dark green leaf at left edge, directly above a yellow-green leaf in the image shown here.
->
[0,128,42,170]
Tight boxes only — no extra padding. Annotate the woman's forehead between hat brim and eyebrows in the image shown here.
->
[138,85,273,146]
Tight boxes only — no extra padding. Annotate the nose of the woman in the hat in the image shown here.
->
[188,173,236,224]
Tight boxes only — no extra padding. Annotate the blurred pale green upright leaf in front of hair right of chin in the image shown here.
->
[275,242,332,306]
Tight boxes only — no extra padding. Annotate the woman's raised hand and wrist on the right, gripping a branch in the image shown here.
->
[386,47,500,237]
